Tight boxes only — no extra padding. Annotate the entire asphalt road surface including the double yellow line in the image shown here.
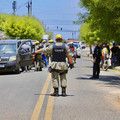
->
[0,50,120,120]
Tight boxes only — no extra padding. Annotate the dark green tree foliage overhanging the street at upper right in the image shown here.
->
[80,0,120,42]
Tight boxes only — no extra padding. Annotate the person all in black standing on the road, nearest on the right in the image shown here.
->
[91,44,102,79]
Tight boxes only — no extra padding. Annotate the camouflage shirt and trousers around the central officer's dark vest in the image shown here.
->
[46,42,69,95]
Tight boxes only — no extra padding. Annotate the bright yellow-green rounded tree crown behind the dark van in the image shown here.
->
[0,15,45,40]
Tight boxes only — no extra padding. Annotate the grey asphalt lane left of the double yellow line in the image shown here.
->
[0,70,47,120]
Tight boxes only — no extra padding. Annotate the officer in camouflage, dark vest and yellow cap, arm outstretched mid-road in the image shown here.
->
[35,34,69,96]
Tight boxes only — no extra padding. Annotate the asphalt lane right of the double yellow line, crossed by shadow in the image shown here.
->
[53,52,120,120]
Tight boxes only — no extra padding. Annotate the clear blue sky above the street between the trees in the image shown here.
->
[0,0,80,39]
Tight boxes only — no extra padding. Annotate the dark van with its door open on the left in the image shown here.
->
[0,40,32,73]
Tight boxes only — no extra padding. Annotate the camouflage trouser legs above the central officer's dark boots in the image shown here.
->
[51,71,67,88]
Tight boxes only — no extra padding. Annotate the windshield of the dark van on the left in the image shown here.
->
[0,44,16,54]
